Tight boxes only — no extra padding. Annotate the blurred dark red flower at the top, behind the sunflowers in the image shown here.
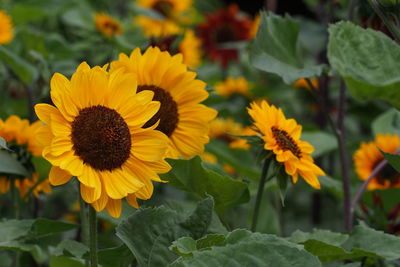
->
[198,5,252,67]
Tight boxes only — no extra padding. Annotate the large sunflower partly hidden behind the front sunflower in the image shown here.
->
[111,47,217,159]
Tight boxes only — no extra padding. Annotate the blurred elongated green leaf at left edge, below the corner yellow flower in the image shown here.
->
[0,46,39,84]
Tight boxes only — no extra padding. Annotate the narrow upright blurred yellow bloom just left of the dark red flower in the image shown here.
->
[179,30,202,69]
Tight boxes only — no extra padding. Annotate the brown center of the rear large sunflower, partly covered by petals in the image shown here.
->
[137,85,179,137]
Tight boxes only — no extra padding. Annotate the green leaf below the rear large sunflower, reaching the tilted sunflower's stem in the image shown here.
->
[164,157,249,212]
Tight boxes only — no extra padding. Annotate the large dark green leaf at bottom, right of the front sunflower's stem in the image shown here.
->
[116,198,213,266]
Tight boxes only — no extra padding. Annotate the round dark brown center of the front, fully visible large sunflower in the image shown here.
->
[71,106,131,171]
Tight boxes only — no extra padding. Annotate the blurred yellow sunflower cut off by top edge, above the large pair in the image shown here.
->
[134,0,192,37]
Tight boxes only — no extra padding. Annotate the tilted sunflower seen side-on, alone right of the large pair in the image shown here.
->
[248,101,325,189]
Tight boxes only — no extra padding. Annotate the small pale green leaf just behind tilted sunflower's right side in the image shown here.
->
[301,131,337,158]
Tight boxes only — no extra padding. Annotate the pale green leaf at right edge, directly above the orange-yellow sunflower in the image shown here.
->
[372,108,400,136]
